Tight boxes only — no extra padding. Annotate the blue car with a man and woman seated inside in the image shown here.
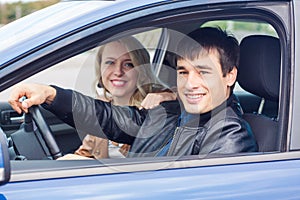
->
[0,0,300,200]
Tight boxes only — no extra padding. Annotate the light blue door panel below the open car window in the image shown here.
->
[1,159,300,200]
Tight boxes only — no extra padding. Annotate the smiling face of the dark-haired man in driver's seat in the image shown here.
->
[177,49,237,114]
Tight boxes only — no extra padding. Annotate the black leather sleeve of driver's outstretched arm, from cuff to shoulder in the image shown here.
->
[44,87,180,145]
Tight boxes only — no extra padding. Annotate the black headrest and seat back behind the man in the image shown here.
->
[238,35,281,152]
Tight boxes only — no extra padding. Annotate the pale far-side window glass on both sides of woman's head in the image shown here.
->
[0,28,162,101]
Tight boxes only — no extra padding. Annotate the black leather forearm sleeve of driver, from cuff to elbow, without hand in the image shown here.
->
[43,86,146,144]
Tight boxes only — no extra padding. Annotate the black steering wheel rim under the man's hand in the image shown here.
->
[28,106,62,159]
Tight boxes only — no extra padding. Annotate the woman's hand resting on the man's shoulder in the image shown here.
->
[141,92,177,109]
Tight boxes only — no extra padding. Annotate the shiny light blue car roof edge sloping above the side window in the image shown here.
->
[0,0,284,69]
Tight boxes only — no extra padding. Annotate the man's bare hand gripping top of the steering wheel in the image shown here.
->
[8,84,56,114]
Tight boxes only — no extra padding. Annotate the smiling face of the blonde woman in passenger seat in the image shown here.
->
[101,42,138,104]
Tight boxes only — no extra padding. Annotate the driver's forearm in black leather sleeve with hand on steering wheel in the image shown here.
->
[9,84,144,144]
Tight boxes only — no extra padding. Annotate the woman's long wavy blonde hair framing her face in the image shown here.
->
[96,36,169,107]
